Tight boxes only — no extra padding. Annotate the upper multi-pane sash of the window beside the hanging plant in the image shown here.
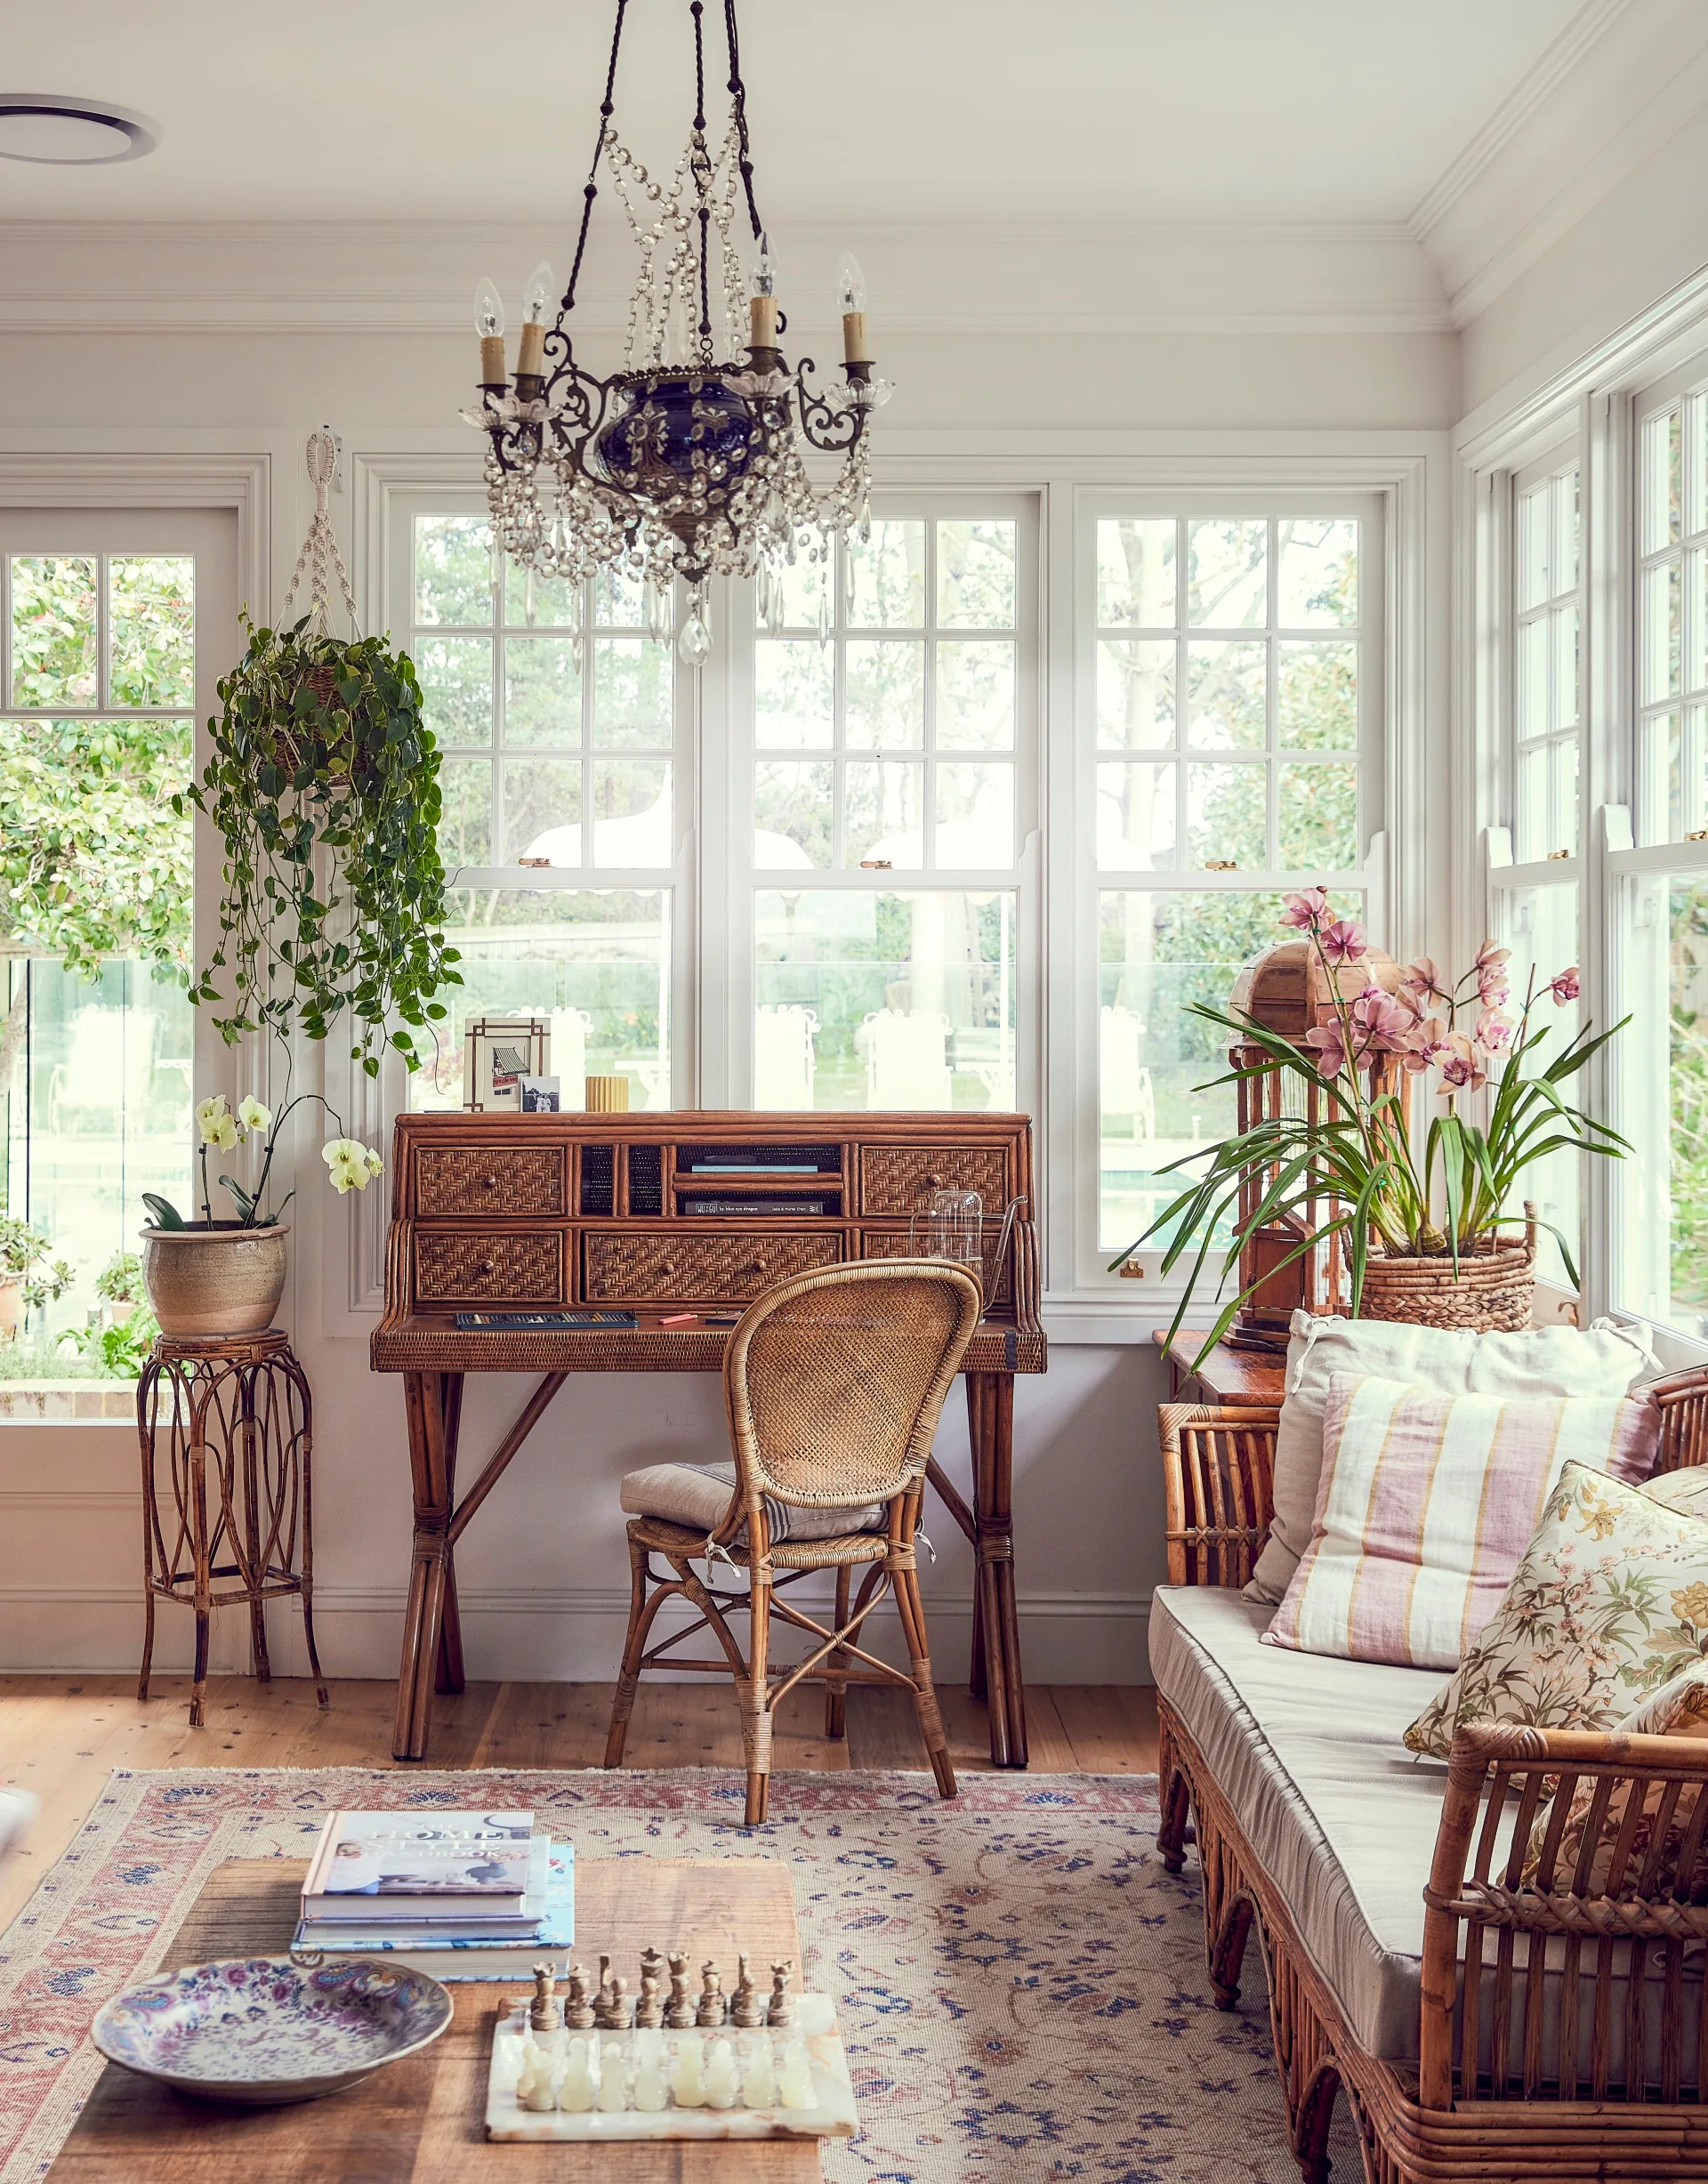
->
[411,513,677,872]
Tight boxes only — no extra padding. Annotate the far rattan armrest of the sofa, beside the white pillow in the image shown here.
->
[1157,1402,1280,1590]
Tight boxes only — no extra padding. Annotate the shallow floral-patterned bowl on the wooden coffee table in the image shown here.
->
[90,1957,452,2106]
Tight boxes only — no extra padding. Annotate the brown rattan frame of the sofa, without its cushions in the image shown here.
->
[1157,1372,1708,2184]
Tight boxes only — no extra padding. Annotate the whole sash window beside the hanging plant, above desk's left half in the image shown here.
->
[393,509,686,1108]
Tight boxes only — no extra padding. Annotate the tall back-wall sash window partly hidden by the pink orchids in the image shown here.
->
[1079,496,1382,1282]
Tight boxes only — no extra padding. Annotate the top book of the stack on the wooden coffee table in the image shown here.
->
[302,1813,533,1926]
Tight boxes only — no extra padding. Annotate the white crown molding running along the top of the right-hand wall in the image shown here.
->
[1406,0,1708,327]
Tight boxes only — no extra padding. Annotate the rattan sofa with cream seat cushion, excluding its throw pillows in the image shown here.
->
[1151,1374,1708,2184]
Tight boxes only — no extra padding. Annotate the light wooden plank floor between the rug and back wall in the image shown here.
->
[0,1675,1156,1926]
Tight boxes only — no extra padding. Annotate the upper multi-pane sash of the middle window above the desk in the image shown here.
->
[753,515,1020,874]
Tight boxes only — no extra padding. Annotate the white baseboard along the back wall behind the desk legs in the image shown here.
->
[0,1584,1151,1684]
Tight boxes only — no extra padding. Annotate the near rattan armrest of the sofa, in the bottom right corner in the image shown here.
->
[1417,1723,1708,2110]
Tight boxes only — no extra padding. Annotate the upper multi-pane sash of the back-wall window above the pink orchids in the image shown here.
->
[1094,515,1361,874]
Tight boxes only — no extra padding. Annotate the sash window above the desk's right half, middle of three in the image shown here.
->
[732,500,1037,1112]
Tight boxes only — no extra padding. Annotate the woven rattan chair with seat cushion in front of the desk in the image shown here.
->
[605,1258,980,1828]
